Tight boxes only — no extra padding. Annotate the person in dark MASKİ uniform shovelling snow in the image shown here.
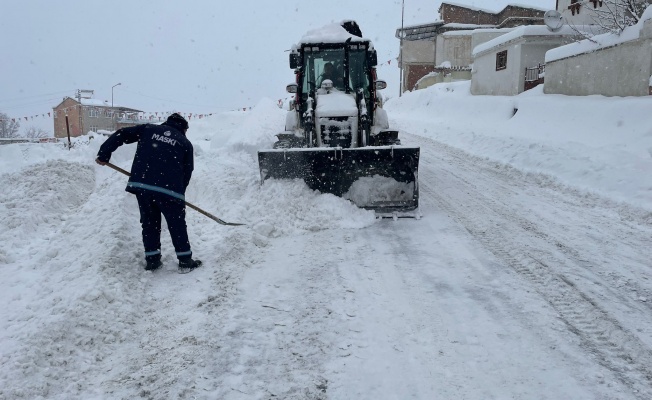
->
[95,113,201,272]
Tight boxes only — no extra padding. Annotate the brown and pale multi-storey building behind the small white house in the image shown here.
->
[396,2,546,92]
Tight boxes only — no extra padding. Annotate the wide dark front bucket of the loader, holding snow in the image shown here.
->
[258,146,419,213]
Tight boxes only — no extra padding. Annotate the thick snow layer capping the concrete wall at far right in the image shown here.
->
[545,6,652,62]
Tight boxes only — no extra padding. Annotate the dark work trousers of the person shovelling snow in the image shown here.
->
[136,191,192,261]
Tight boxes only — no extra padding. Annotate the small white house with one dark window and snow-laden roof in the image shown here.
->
[471,25,579,96]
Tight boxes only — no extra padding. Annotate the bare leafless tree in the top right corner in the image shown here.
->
[587,0,652,35]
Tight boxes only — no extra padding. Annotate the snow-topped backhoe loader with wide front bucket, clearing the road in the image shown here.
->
[258,21,419,216]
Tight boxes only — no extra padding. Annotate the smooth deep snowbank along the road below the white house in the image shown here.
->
[385,81,652,209]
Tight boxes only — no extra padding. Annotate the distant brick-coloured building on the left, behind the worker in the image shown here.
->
[52,91,144,138]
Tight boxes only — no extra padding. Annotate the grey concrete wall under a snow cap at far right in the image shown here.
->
[544,20,652,96]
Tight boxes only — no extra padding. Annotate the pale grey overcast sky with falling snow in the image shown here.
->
[0,0,555,130]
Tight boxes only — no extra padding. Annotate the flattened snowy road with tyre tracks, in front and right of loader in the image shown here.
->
[183,129,652,399]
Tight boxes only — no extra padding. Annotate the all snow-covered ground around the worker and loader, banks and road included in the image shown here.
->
[0,83,652,399]
